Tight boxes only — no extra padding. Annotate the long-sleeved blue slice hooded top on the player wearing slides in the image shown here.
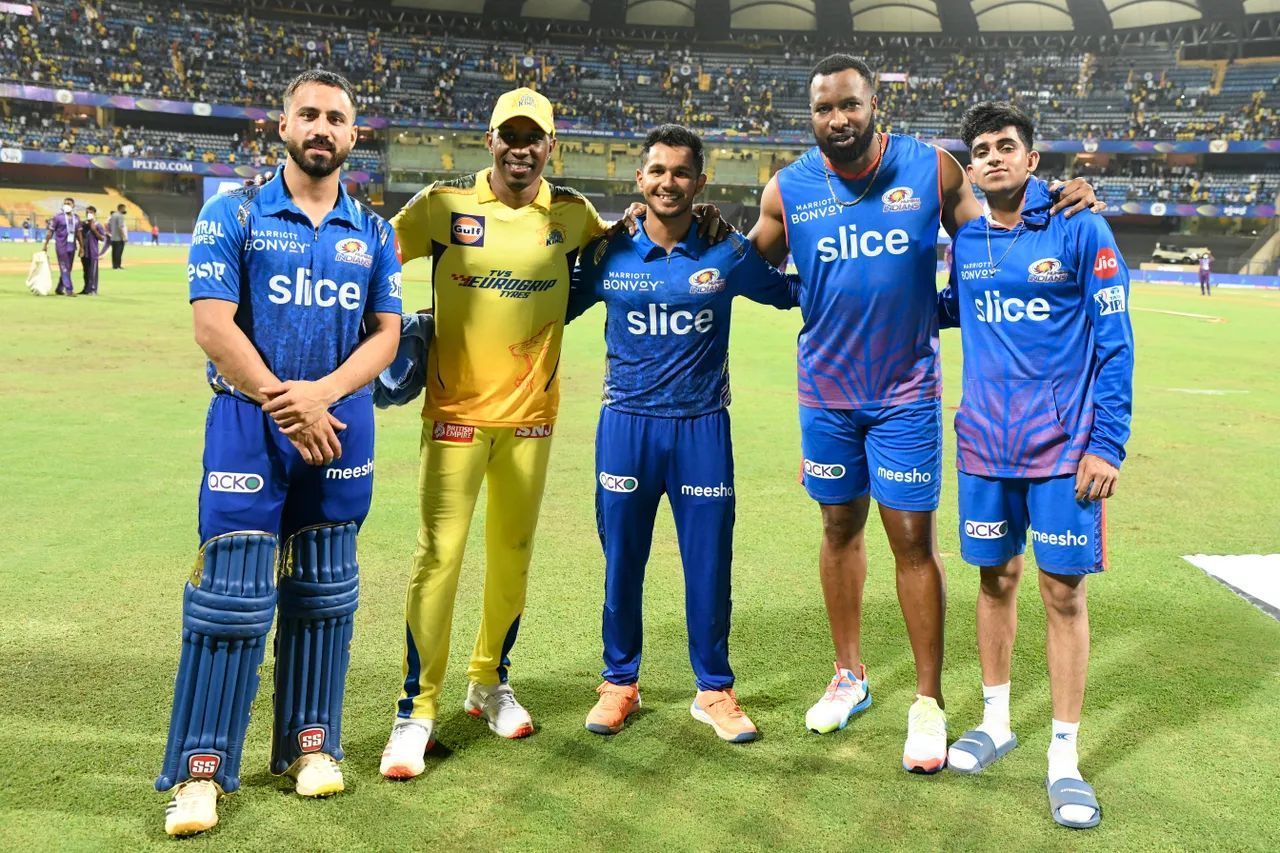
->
[938,178,1133,478]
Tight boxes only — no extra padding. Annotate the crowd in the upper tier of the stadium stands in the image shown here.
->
[0,0,1280,140]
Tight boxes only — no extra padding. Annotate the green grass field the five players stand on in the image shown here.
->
[0,246,1280,850]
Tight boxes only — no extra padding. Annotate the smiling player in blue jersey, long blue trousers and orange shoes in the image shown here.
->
[568,124,796,743]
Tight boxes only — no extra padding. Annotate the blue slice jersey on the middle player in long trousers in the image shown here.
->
[568,220,797,418]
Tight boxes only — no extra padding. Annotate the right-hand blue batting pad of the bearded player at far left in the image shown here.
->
[271,523,360,774]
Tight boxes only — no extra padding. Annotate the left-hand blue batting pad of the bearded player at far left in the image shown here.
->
[156,532,275,792]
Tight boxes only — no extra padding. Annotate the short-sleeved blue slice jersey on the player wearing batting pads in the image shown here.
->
[187,168,401,400]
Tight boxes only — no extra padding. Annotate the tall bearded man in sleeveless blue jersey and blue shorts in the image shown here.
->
[751,54,1093,772]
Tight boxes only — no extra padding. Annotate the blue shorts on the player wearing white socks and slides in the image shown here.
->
[959,471,1107,575]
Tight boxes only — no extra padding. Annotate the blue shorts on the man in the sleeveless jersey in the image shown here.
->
[800,400,942,512]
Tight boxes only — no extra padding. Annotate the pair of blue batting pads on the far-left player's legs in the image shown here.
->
[156,523,360,793]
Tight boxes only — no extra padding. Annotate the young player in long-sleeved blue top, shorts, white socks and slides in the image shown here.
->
[938,104,1133,829]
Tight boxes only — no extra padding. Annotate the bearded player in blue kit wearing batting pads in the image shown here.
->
[156,70,401,835]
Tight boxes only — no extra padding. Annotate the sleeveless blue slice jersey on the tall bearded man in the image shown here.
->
[777,133,942,409]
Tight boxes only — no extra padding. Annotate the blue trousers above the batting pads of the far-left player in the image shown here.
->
[200,394,374,543]
